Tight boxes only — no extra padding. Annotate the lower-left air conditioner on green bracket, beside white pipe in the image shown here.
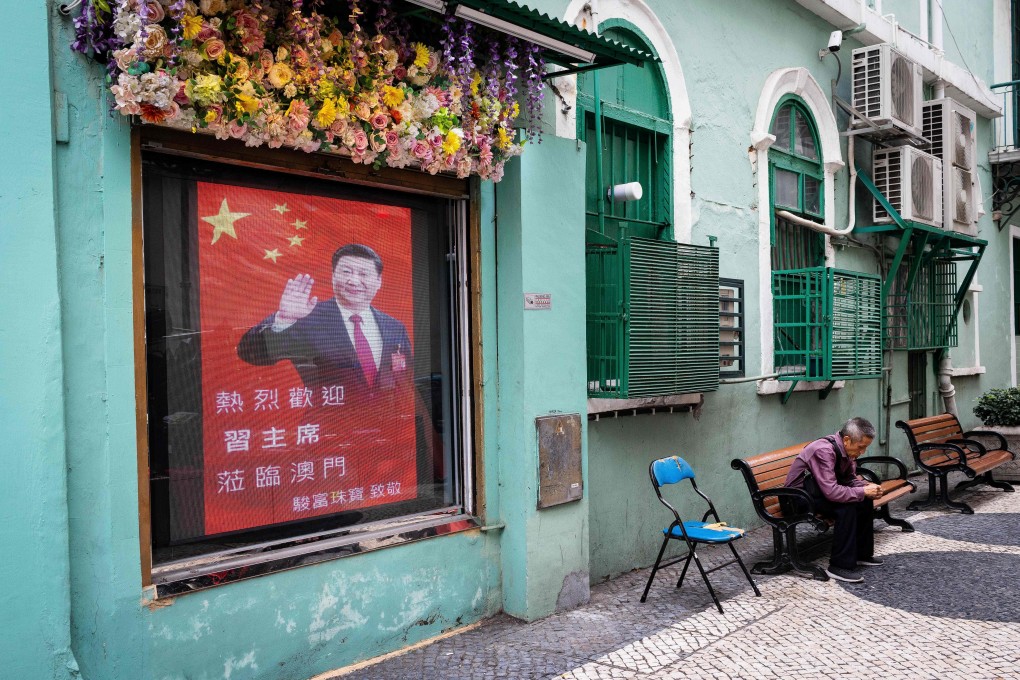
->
[872,147,942,227]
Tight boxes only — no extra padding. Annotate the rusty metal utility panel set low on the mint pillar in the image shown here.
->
[534,413,584,510]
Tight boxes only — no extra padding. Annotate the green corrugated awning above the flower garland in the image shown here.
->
[395,0,658,70]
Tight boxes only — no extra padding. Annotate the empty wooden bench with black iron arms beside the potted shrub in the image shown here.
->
[896,413,1016,515]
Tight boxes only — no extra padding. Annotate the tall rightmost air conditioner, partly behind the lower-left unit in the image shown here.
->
[923,98,977,233]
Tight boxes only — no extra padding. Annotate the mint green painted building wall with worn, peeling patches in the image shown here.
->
[0,0,1012,680]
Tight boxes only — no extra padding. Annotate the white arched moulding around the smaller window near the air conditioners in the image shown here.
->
[750,68,846,395]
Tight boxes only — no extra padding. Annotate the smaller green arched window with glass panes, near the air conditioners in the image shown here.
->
[768,95,825,270]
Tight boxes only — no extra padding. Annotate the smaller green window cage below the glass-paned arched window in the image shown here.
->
[772,267,882,380]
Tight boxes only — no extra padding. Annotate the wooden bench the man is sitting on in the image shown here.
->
[730,441,915,581]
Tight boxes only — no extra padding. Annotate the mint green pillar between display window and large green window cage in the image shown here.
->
[488,137,589,620]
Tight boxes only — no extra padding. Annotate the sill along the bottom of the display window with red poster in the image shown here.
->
[147,509,479,599]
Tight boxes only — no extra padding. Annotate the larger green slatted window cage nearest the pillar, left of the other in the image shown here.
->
[588,234,719,399]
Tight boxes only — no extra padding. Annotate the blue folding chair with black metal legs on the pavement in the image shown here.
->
[641,456,762,614]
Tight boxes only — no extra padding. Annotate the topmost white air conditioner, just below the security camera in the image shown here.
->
[853,44,923,137]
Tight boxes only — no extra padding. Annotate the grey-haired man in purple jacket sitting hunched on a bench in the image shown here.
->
[785,418,882,583]
